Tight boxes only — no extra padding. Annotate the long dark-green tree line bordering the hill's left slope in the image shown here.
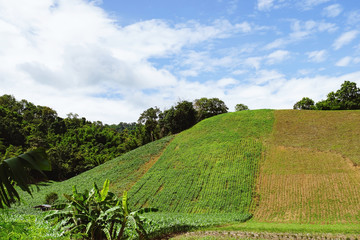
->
[0,94,243,180]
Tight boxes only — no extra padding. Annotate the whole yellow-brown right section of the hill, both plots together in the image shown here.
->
[255,111,360,224]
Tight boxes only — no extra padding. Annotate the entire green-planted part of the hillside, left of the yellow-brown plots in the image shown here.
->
[19,110,274,213]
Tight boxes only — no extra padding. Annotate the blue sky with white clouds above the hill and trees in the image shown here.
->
[0,0,360,124]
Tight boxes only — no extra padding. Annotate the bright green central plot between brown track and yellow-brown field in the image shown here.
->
[129,110,273,213]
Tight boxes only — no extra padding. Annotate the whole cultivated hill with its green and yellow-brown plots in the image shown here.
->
[14,110,360,237]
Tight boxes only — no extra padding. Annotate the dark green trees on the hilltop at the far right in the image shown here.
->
[293,81,360,110]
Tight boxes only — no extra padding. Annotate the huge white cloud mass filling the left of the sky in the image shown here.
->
[0,0,252,123]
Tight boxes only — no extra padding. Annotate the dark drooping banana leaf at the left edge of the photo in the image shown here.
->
[0,149,51,208]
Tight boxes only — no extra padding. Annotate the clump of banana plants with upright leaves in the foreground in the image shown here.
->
[46,180,154,240]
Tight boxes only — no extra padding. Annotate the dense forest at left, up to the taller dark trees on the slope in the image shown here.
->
[0,95,144,180]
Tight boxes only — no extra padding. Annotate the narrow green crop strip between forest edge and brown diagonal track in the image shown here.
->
[18,136,173,212]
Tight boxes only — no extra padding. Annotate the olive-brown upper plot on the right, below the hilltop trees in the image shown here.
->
[272,110,360,164]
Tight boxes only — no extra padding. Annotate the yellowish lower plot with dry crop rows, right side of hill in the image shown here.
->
[255,146,360,224]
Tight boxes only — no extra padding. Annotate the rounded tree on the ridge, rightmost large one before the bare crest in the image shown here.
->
[194,98,228,121]
